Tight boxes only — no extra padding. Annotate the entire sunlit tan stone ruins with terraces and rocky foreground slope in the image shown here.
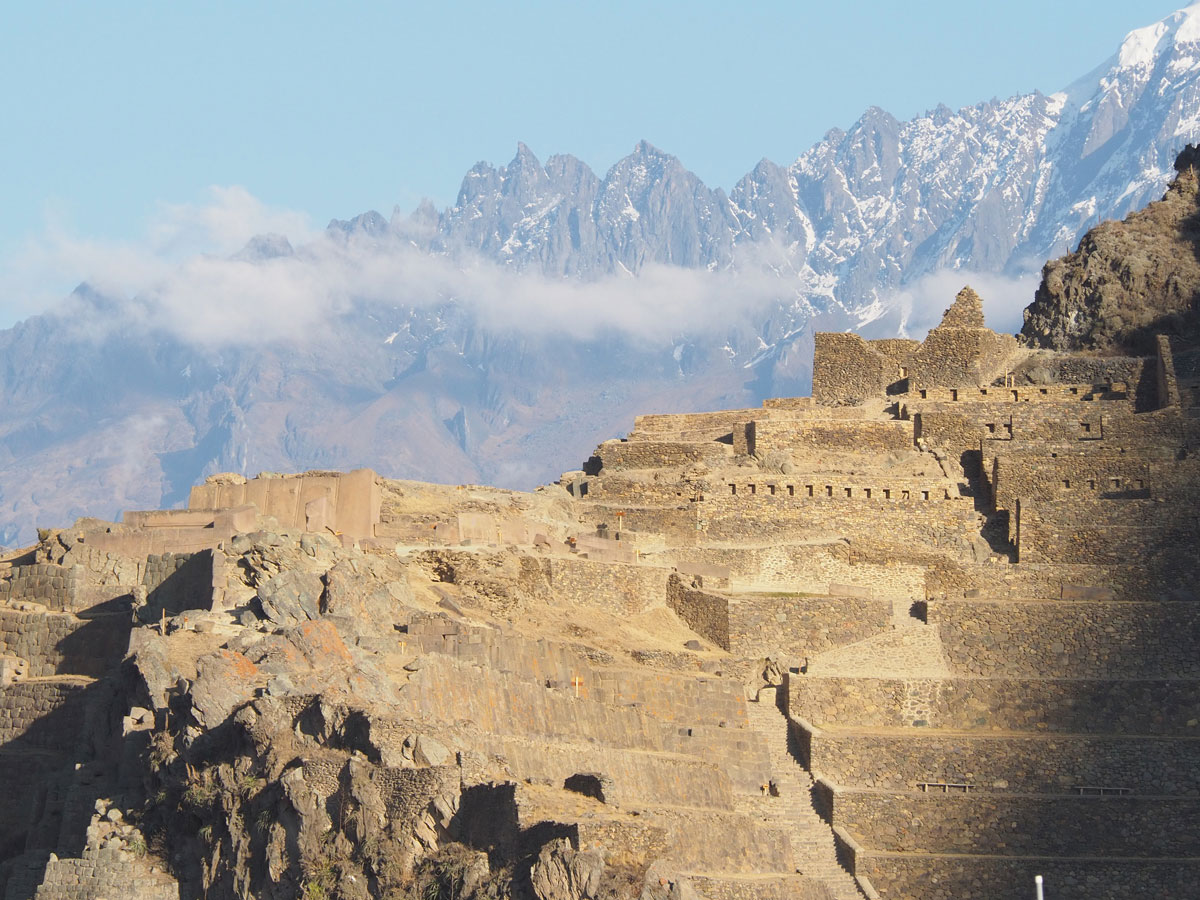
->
[0,168,1200,900]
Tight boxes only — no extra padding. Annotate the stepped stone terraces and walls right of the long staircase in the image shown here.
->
[564,286,1200,900]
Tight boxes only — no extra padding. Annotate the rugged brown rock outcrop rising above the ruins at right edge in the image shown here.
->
[1021,145,1200,353]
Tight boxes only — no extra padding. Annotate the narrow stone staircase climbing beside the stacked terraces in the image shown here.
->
[739,688,863,900]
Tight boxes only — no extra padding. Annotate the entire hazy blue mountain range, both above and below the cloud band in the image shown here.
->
[0,6,1200,544]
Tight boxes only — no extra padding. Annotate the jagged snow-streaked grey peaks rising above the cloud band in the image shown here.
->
[391,6,1200,336]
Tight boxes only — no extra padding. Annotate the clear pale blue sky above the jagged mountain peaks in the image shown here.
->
[0,0,1182,314]
